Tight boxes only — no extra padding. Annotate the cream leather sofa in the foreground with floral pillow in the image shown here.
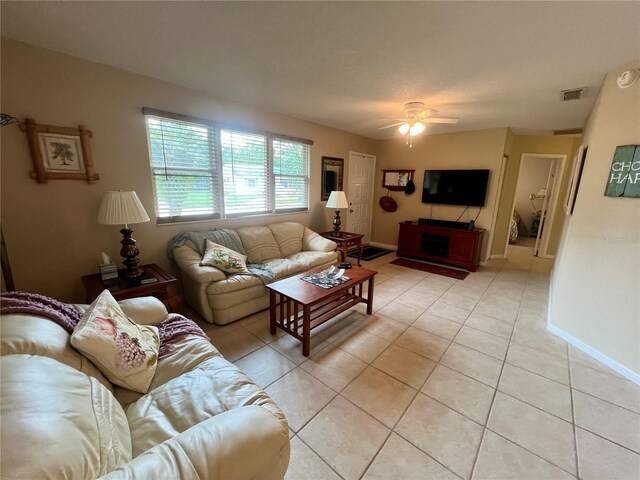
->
[0,297,290,480]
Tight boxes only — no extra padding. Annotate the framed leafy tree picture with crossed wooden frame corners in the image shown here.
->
[21,118,100,183]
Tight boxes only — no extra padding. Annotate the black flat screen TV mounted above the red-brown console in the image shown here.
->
[422,170,489,207]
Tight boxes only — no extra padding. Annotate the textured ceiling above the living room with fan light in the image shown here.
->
[1,1,640,138]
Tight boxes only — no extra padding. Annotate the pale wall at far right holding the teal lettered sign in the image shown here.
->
[549,61,640,375]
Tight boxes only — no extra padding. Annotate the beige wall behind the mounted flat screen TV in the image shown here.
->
[372,128,507,258]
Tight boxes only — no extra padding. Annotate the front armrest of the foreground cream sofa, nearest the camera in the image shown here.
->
[101,405,290,480]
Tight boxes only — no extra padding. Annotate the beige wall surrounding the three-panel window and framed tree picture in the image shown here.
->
[1,39,378,301]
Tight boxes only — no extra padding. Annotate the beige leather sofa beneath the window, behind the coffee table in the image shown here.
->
[173,222,338,325]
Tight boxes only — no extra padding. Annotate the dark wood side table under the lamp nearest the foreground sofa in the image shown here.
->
[82,263,178,312]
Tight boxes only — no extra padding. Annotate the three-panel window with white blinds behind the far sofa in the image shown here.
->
[144,109,312,223]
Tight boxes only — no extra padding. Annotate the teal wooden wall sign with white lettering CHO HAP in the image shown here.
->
[604,145,640,198]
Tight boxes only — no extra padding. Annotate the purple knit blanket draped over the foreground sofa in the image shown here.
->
[0,292,210,358]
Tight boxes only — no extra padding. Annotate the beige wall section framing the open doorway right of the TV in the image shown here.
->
[491,135,580,256]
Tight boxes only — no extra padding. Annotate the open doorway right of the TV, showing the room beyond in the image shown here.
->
[505,153,566,258]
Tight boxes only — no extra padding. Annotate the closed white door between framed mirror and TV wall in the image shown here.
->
[346,152,376,245]
